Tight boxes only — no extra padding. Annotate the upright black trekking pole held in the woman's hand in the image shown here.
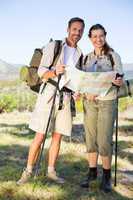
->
[114,73,123,187]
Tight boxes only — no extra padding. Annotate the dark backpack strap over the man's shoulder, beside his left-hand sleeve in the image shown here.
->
[49,40,62,69]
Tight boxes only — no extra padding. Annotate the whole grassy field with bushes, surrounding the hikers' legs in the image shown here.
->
[0,81,133,200]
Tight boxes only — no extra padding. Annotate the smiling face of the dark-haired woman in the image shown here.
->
[90,29,106,49]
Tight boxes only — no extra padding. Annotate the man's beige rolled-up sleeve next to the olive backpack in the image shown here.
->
[38,42,55,78]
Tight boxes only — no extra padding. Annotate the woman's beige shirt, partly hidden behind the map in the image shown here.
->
[83,51,123,100]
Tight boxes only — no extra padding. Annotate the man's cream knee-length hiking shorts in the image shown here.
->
[29,84,72,136]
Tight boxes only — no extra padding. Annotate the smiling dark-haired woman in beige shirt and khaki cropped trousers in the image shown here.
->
[81,24,123,192]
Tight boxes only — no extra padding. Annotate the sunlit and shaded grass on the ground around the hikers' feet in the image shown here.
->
[0,113,133,200]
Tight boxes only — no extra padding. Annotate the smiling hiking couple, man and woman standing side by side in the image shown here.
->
[17,17,123,192]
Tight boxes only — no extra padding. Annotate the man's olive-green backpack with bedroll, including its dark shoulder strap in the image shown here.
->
[20,40,62,93]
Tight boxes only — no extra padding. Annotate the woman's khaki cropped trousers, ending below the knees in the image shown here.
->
[83,100,116,156]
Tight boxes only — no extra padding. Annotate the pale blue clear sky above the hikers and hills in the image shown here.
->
[0,0,133,65]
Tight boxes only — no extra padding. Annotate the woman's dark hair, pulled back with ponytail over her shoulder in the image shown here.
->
[88,24,114,55]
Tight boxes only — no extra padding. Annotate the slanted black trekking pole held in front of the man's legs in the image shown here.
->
[33,74,61,190]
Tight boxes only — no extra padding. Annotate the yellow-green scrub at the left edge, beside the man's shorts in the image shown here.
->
[0,80,37,113]
